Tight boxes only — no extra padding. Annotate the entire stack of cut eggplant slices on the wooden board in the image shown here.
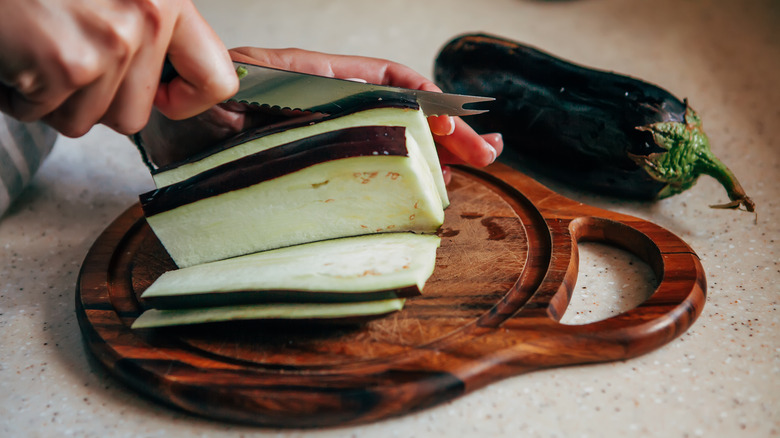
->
[133,98,449,328]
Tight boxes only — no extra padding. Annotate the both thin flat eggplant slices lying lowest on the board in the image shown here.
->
[133,233,440,328]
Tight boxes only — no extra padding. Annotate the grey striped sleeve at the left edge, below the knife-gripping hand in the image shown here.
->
[0,113,57,216]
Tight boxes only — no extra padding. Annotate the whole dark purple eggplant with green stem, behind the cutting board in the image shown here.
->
[434,34,755,211]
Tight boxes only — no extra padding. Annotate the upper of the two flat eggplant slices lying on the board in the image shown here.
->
[135,233,440,309]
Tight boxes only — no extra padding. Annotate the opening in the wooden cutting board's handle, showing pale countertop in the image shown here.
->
[560,242,658,325]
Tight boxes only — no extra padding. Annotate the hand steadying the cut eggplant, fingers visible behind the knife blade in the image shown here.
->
[230,47,504,180]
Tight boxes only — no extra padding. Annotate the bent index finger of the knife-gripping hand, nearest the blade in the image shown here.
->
[154,2,238,119]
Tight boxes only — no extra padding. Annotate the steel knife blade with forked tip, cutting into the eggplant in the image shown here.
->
[161,60,495,116]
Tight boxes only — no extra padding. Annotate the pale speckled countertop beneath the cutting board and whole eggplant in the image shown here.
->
[0,0,780,438]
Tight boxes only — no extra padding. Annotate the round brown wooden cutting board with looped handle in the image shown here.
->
[76,164,706,427]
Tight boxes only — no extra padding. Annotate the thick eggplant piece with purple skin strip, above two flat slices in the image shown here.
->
[141,126,444,268]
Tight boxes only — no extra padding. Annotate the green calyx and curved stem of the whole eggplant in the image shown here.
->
[631,101,755,212]
